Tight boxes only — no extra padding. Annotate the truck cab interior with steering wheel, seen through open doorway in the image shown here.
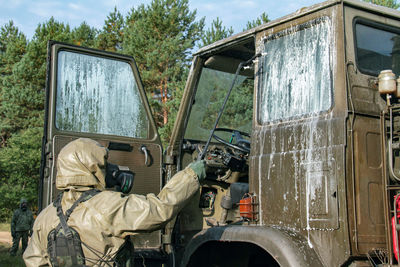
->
[177,38,258,246]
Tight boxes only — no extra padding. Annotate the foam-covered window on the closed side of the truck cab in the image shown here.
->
[258,18,333,123]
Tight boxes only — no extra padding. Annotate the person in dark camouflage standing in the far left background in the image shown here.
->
[10,199,33,256]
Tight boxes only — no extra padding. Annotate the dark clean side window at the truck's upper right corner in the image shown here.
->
[355,20,400,76]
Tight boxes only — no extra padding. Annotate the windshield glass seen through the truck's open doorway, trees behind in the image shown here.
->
[185,68,254,141]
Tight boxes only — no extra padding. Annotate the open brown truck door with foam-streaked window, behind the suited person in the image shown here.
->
[39,42,162,251]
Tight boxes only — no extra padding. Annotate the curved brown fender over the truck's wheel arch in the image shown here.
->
[181,226,323,267]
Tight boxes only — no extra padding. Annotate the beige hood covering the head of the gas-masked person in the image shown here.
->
[56,138,108,190]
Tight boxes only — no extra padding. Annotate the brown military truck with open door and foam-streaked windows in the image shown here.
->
[40,0,400,266]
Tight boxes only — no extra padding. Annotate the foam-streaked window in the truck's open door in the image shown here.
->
[55,51,149,138]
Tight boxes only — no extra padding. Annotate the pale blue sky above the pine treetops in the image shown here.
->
[0,0,322,39]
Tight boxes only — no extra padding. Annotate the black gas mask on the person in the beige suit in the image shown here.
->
[106,163,134,194]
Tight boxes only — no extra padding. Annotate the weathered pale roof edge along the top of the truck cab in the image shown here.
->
[194,0,400,55]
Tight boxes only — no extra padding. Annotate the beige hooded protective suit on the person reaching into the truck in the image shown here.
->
[23,138,199,267]
